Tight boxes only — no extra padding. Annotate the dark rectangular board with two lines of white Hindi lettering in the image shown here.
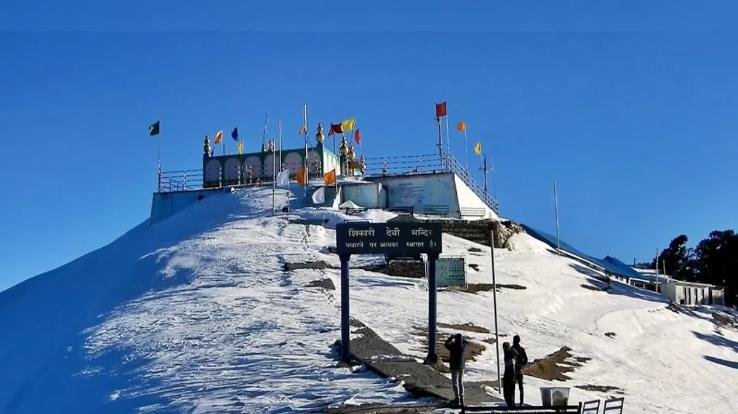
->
[336,222,441,256]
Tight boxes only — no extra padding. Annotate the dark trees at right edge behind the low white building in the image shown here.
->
[641,230,738,305]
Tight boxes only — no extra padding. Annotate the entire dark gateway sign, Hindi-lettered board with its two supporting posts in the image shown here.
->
[336,222,442,363]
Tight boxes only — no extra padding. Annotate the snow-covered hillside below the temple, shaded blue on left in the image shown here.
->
[0,189,738,413]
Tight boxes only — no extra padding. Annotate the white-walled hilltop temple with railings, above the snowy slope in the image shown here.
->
[151,124,498,222]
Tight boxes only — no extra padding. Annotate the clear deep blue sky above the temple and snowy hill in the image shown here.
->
[0,1,738,289]
